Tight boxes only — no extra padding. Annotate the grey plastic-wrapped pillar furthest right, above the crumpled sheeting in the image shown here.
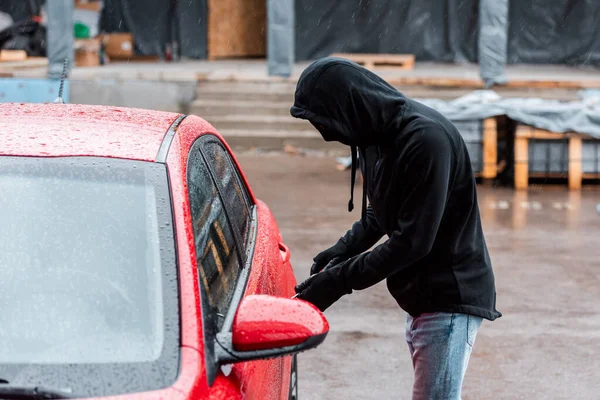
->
[479,0,508,88]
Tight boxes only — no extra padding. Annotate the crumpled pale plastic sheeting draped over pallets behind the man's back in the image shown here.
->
[416,90,600,138]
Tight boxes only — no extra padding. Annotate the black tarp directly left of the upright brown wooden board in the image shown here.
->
[100,0,208,58]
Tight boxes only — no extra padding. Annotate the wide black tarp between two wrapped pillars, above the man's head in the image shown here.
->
[296,0,479,62]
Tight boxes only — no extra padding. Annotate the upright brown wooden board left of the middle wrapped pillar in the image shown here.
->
[207,0,267,60]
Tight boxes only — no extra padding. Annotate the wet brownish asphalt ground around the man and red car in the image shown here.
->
[238,153,600,400]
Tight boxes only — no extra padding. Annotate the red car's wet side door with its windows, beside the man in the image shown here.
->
[188,135,291,400]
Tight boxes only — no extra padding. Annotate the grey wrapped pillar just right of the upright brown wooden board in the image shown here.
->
[267,0,294,77]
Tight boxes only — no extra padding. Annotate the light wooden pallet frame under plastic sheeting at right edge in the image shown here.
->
[514,125,600,190]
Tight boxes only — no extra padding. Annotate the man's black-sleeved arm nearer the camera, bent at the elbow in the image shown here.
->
[339,130,453,290]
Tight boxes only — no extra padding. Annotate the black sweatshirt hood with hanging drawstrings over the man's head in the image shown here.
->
[290,57,406,218]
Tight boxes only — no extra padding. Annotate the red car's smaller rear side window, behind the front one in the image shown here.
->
[203,141,251,253]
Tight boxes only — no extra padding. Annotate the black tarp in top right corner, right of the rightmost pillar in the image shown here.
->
[508,0,600,65]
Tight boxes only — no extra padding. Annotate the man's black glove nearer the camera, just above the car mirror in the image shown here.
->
[295,263,352,311]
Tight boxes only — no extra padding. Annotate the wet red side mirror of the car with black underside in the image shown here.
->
[215,295,329,364]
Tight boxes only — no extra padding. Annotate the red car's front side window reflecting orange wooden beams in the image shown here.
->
[188,145,242,330]
